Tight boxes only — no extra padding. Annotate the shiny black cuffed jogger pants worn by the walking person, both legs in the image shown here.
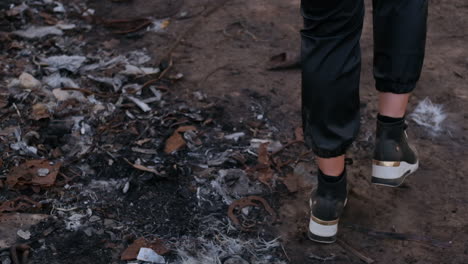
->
[301,0,428,158]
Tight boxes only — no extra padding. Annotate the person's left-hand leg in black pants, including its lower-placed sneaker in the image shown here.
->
[301,0,364,243]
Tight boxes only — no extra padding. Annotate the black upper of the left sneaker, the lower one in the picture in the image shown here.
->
[311,171,348,221]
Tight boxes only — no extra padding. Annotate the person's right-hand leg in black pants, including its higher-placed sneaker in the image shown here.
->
[372,0,428,187]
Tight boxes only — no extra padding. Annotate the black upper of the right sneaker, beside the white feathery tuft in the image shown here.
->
[374,120,418,164]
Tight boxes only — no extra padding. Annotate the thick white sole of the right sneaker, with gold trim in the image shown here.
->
[371,161,419,187]
